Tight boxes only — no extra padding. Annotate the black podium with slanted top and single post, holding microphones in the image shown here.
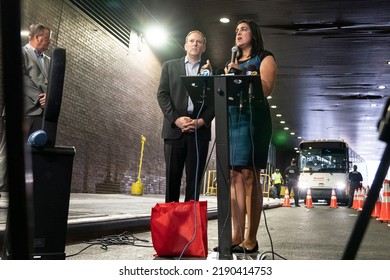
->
[182,75,266,260]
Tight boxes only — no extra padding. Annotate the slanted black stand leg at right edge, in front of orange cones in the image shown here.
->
[342,98,390,260]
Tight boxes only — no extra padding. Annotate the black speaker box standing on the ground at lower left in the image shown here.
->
[32,147,75,259]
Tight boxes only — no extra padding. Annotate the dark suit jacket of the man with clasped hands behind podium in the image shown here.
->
[157,57,214,140]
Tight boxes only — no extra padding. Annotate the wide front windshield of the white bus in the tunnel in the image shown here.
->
[299,148,348,173]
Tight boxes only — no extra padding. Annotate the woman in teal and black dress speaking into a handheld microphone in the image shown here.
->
[225,20,277,253]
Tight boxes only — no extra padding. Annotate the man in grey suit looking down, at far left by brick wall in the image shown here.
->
[22,23,51,139]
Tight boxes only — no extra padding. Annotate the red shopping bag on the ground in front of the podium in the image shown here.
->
[150,201,207,257]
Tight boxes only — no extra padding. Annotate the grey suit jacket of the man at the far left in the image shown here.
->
[22,44,50,116]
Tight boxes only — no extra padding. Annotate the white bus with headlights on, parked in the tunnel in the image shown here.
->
[298,140,367,204]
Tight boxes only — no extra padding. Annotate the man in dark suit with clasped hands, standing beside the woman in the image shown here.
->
[157,30,214,202]
